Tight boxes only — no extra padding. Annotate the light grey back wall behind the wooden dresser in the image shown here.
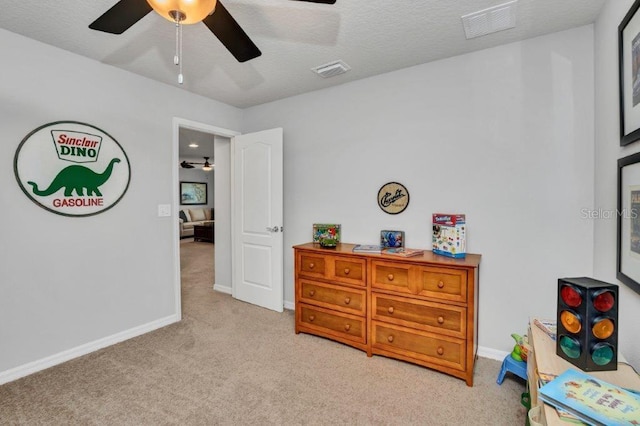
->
[243,26,594,351]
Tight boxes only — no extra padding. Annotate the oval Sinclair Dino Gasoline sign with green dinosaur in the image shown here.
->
[13,121,131,216]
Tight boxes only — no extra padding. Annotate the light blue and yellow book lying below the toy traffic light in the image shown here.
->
[539,369,640,425]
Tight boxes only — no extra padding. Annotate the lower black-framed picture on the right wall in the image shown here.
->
[616,153,640,293]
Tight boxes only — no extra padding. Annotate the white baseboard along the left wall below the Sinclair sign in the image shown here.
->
[0,315,180,385]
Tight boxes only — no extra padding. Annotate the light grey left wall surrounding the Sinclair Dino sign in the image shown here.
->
[0,30,241,383]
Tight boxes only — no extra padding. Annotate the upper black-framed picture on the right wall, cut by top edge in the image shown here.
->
[618,0,640,146]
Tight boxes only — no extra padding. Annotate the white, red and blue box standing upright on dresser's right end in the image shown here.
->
[432,213,467,258]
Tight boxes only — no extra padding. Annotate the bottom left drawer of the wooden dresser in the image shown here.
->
[296,303,367,343]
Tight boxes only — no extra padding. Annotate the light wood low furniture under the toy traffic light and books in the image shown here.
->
[527,318,640,426]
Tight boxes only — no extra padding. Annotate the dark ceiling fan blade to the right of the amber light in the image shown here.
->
[202,1,262,62]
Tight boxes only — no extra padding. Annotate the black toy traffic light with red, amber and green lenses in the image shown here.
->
[556,277,618,371]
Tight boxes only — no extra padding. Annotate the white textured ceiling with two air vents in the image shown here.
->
[0,0,607,108]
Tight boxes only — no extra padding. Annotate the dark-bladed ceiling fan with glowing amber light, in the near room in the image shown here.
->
[89,0,336,65]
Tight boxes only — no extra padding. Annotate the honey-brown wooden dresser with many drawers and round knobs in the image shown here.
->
[294,243,480,386]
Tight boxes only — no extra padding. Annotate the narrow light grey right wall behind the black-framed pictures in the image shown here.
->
[594,0,640,369]
